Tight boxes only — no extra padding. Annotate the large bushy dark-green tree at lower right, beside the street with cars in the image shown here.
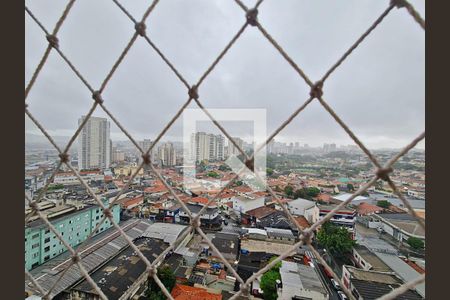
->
[317,221,356,257]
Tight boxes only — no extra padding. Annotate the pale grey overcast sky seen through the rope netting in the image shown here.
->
[25,0,425,148]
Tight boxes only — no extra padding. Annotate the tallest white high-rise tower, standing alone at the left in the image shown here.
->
[78,116,111,170]
